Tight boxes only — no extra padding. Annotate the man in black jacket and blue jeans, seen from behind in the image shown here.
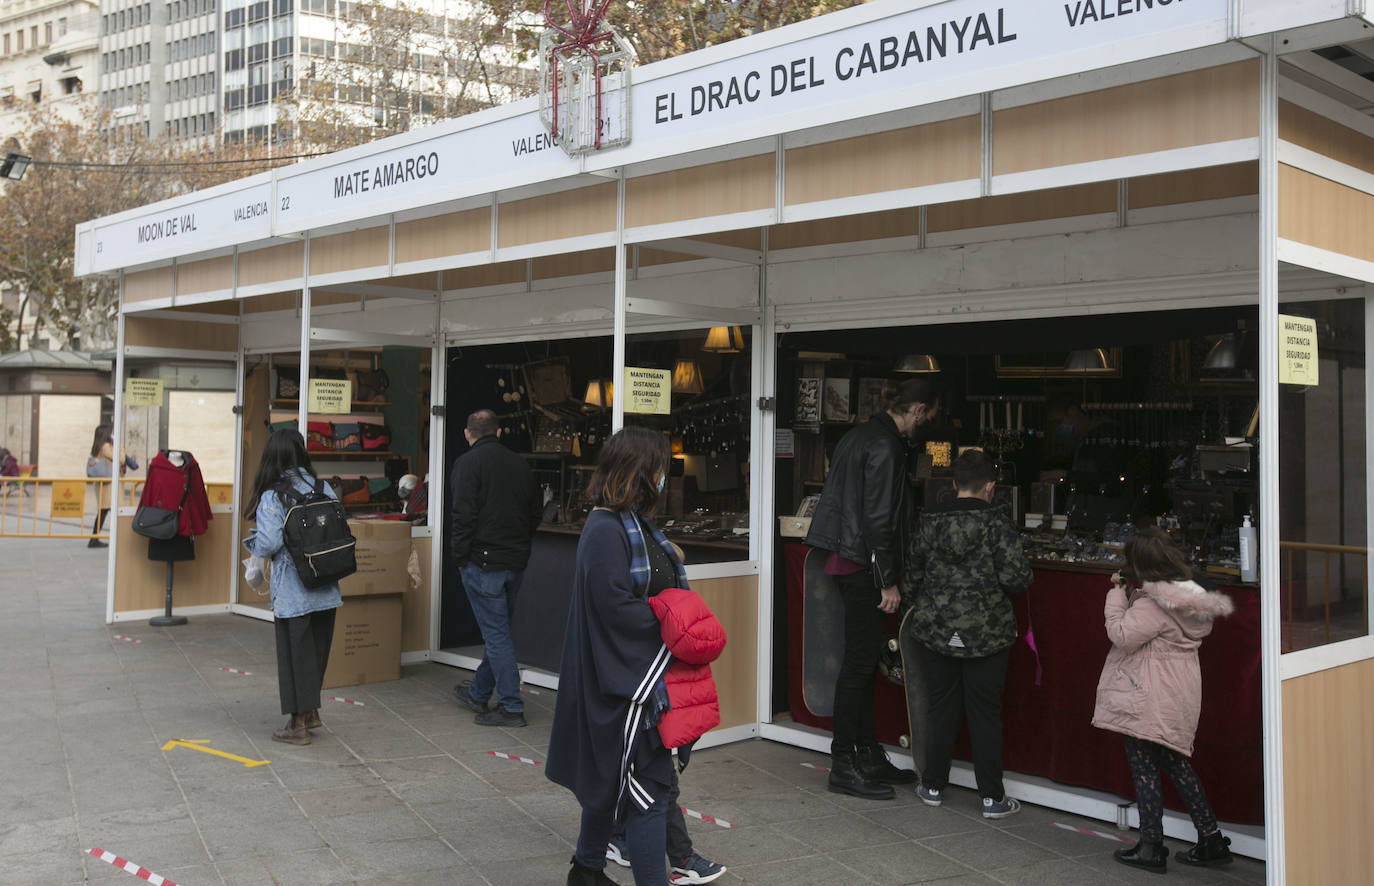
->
[449,409,544,727]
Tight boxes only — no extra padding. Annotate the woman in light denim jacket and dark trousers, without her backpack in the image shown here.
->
[243,429,344,745]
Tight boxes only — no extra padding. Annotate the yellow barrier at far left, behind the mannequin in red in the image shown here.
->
[0,477,234,538]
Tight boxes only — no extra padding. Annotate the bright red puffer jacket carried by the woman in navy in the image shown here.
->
[649,588,725,747]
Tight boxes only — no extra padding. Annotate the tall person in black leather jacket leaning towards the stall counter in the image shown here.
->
[807,378,940,799]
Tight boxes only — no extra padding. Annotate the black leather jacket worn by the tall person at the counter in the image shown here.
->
[807,412,907,588]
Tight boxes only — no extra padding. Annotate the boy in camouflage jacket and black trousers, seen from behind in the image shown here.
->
[901,449,1031,819]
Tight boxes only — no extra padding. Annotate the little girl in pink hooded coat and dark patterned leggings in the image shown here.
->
[1092,527,1235,874]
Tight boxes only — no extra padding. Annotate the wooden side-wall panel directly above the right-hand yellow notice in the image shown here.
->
[1279,163,1374,261]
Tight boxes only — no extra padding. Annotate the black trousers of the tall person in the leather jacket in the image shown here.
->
[831,570,888,753]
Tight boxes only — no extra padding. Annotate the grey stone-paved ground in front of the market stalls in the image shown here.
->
[0,538,1264,886]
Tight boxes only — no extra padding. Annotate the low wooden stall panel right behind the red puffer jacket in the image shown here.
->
[692,576,758,728]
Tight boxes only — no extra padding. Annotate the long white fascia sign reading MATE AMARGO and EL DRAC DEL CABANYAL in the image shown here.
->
[85,0,1231,273]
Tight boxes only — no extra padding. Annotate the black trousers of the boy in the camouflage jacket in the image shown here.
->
[921,648,1011,799]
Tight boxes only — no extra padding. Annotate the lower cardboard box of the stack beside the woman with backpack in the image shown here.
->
[323,593,401,690]
